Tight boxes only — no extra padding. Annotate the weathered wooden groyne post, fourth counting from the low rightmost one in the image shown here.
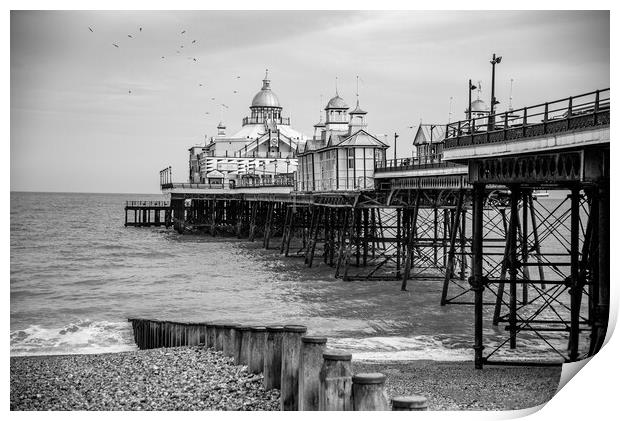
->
[299,336,327,411]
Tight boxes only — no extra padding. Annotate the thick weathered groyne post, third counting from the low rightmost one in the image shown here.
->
[319,351,353,411]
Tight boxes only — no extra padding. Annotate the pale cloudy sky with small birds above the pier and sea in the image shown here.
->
[10,11,610,193]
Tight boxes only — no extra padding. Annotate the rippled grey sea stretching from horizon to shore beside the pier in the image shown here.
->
[10,192,572,361]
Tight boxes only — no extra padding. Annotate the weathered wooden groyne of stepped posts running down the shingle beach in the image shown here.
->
[129,318,428,411]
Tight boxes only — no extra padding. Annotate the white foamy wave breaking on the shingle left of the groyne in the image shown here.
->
[11,320,137,356]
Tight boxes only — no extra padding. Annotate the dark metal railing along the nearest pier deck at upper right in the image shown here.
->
[444,88,611,149]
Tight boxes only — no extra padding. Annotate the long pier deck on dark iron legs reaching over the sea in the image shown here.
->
[126,89,610,368]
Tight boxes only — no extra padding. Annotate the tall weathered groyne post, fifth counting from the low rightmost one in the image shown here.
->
[280,325,307,411]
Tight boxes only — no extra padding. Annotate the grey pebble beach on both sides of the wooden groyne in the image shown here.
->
[10,347,561,411]
